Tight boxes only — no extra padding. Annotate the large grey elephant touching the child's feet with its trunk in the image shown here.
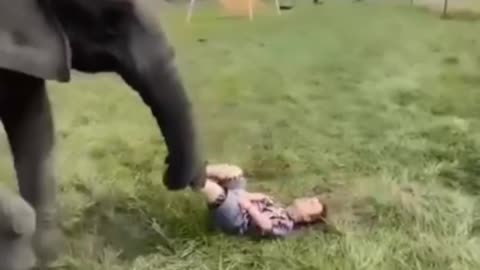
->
[0,0,206,262]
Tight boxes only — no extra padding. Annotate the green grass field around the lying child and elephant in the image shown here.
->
[0,2,480,270]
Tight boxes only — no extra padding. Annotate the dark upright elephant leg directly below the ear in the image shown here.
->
[0,71,60,264]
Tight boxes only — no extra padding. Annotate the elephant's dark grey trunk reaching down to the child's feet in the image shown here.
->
[119,21,205,190]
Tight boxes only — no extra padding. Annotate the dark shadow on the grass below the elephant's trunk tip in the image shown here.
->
[61,178,212,263]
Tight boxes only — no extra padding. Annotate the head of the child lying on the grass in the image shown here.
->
[287,197,326,223]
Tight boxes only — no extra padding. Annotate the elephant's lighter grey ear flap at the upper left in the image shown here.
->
[0,0,71,82]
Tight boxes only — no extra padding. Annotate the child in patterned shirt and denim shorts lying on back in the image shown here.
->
[201,164,327,237]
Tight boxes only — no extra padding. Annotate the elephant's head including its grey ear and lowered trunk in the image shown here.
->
[0,0,205,190]
